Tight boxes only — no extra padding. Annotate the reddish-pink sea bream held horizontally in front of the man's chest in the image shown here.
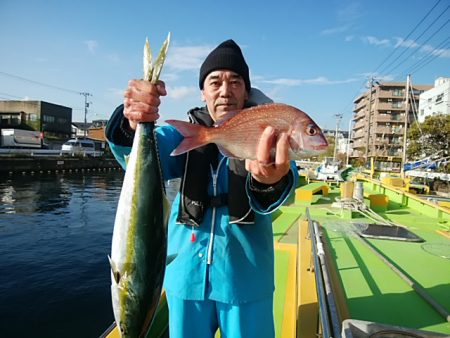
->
[166,103,328,160]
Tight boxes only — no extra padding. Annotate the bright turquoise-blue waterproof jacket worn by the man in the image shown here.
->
[109,121,297,304]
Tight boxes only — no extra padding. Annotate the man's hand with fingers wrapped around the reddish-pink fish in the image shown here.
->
[245,126,290,184]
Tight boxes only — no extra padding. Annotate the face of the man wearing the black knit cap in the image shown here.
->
[202,70,248,122]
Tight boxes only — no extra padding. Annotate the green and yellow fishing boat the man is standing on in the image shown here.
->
[100,178,450,338]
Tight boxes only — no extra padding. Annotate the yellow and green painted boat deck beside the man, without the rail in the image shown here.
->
[105,178,450,338]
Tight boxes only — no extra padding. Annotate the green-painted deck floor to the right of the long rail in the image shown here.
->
[310,187,450,334]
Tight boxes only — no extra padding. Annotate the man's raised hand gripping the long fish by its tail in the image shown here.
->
[123,80,167,129]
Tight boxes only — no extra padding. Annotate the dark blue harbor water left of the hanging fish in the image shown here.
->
[0,171,158,338]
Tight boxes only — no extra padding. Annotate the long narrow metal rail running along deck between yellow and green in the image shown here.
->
[306,208,341,338]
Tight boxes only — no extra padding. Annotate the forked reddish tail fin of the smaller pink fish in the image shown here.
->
[166,120,210,156]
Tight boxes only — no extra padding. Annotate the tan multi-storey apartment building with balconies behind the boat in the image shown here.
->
[350,82,432,159]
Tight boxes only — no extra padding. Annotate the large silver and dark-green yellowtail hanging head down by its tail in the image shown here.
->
[110,34,170,338]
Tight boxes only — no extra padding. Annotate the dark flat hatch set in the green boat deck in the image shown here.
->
[357,223,424,242]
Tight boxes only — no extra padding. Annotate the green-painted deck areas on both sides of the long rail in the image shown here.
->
[273,183,450,337]
